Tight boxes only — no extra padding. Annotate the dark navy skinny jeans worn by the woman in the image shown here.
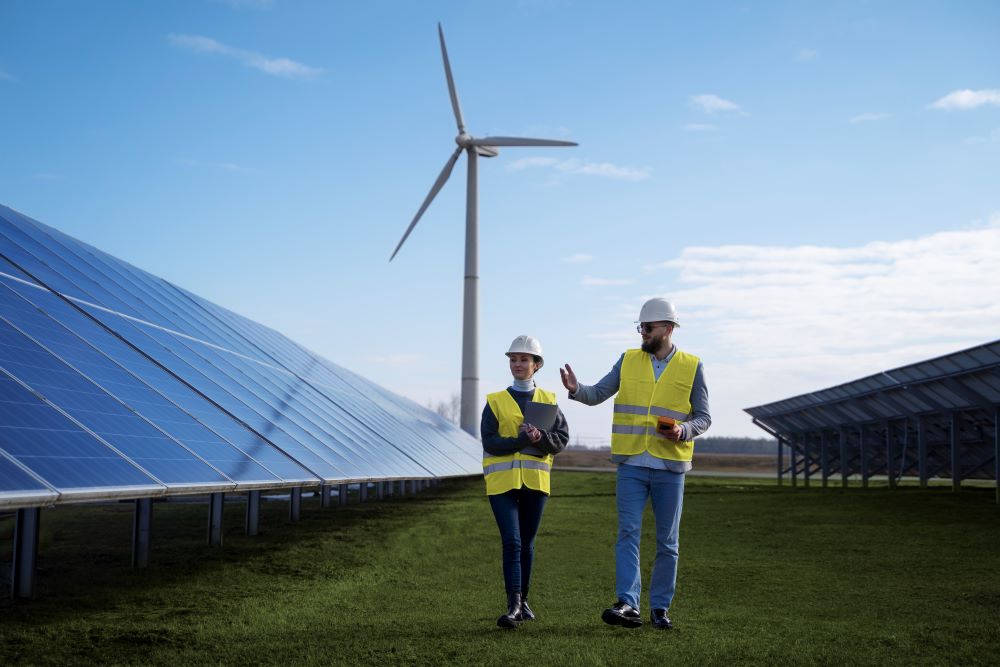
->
[489,486,549,594]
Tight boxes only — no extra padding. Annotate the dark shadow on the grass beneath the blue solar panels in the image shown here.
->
[0,480,481,620]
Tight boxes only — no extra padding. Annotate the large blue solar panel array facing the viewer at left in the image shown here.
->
[0,206,482,507]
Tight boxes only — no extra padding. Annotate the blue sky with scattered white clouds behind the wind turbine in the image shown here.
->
[0,0,1000,443]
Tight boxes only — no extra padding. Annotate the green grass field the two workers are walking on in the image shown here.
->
[0,473,1000,665]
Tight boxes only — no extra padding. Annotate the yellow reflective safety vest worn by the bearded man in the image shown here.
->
[611,350,698,461]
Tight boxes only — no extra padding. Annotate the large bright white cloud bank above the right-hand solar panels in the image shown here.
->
[648,216,1000,370]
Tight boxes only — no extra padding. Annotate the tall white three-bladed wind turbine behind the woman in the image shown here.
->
[389,23,577,436]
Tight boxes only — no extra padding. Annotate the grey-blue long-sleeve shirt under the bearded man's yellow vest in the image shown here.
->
[569,345,712,472]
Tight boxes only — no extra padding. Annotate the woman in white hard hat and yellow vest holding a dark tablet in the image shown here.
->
[479,336,569,628]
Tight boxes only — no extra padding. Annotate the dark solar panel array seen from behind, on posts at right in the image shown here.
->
[745,340,1000,485]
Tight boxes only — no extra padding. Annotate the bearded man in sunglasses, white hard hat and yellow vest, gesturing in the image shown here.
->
[559,298,712,630]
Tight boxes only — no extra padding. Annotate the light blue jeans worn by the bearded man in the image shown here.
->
[615,464,684,609]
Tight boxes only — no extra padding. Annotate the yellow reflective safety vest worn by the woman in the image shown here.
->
[483,387,556,496]
